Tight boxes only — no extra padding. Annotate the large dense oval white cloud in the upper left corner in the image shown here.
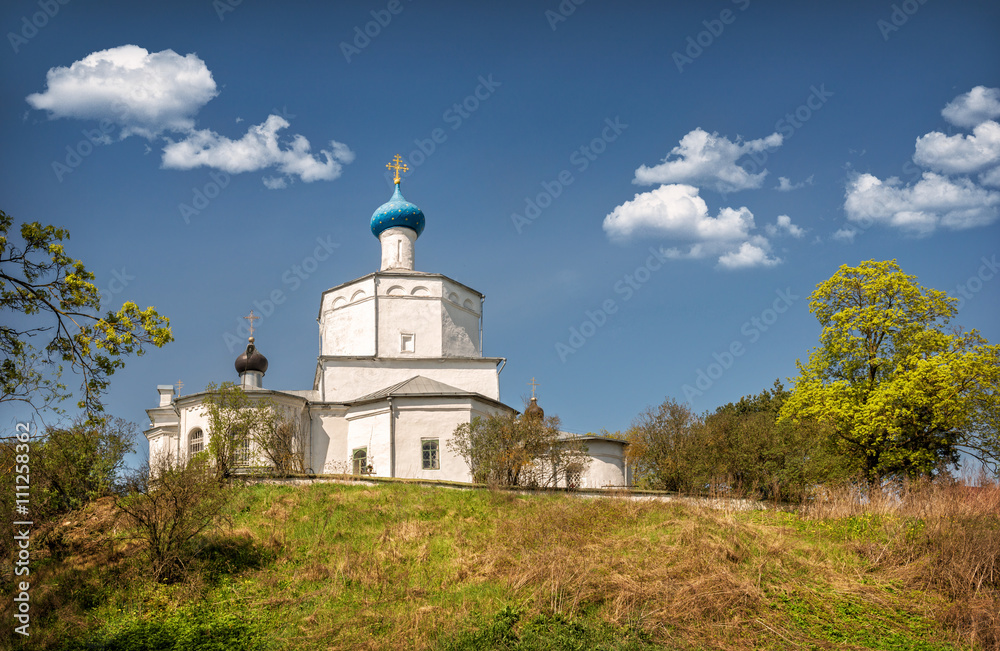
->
[27,45,218,139]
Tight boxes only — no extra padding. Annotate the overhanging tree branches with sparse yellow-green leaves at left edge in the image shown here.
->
[0,211,173,418]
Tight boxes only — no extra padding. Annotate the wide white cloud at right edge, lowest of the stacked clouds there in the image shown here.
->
[844,172,1000,235]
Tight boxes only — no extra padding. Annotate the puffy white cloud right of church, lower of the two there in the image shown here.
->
[604,184,780,269]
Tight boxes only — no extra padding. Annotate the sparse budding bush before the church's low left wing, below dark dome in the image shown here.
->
[199,382,305,479]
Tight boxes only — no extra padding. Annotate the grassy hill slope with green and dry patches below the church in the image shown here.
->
[0,484,1000,650]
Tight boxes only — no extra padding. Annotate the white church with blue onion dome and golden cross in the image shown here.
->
[145,156,629,488]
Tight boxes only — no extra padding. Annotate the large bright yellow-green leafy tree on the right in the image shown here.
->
[781,260,1000,481]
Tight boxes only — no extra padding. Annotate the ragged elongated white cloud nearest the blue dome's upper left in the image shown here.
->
[163,115,354,183]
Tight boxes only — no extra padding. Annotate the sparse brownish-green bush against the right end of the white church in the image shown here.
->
[448,413,589,486]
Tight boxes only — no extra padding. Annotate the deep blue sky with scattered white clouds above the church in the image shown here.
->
[0,0,1000,458]
